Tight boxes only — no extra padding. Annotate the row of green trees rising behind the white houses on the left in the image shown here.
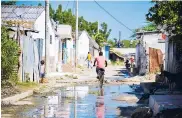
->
[50,5,111,46]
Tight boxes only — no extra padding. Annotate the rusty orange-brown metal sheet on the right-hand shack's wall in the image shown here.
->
[149,48,163,73]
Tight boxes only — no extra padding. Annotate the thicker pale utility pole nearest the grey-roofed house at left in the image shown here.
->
[45,0,49,76]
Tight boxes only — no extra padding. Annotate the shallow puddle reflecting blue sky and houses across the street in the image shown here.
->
[1,85,144,118]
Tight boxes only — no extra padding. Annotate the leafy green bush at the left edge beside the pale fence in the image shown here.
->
[1,26,19,81]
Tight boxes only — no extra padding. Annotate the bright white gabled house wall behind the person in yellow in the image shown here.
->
[78,31,89,65]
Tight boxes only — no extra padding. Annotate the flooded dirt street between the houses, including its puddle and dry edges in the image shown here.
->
[2,66,154,118]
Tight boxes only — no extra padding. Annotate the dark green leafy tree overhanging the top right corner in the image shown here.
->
[146,0,182,34]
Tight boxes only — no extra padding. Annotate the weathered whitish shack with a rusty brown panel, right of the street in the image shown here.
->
[136,31,165,75]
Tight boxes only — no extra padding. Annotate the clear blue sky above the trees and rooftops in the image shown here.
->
[14,1,152,39]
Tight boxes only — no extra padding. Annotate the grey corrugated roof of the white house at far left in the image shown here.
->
[1,5,44,21]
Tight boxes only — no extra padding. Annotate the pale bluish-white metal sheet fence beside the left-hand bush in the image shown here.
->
[20,35,39,82]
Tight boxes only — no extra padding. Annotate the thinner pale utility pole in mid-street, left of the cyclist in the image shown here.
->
[75,0,79,72]
